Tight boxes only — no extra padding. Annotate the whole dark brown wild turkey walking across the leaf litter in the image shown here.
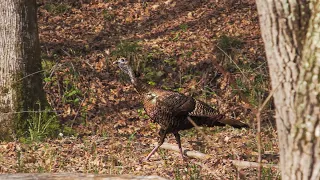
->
[114,58,249,160]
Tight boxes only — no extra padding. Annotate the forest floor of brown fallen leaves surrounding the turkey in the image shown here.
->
[0,0,279,179]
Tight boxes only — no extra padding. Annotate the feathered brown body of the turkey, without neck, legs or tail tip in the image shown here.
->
[143,89,225,133]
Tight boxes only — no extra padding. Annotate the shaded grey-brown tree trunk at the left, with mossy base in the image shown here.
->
[0,0,45,139]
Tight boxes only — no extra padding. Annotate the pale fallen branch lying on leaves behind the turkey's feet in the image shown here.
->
[160,143,278,168]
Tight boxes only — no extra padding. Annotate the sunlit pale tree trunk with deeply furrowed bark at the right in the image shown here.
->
[257,0,320,180]
